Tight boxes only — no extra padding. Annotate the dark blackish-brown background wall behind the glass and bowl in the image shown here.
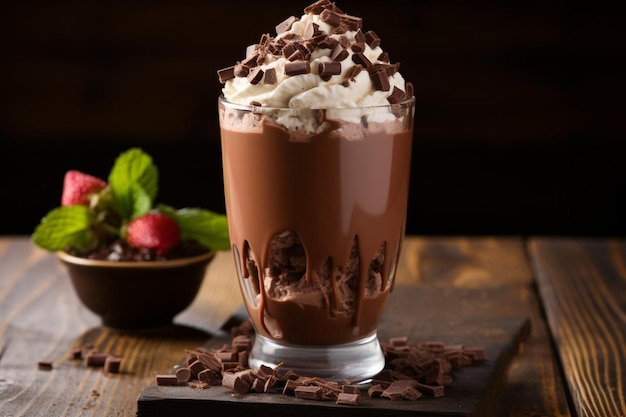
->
[0,0,626,235]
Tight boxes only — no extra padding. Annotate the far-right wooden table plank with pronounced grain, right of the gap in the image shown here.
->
[529,238,626,417]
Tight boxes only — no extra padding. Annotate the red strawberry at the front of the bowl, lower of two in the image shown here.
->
[126,213,180,255]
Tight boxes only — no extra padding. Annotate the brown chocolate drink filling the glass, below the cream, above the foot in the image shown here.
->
[220,106,412,345]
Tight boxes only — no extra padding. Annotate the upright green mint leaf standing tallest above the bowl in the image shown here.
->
[109,148,159,220]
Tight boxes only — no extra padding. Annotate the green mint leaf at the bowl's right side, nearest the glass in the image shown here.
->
[159,204,230,251]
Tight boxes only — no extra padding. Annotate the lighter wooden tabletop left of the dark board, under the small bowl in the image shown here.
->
[0,237,240,417]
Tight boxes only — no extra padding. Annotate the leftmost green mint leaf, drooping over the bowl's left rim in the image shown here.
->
[32,205,94,251]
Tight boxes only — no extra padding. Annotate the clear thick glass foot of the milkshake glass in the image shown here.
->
[249,334,385,383]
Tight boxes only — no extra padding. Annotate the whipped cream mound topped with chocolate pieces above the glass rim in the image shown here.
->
[218,0,413,109]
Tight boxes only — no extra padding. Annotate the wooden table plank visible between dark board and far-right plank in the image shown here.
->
[397,236,571,417]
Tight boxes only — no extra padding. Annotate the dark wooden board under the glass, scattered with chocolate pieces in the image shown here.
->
[137,286,530,417]
